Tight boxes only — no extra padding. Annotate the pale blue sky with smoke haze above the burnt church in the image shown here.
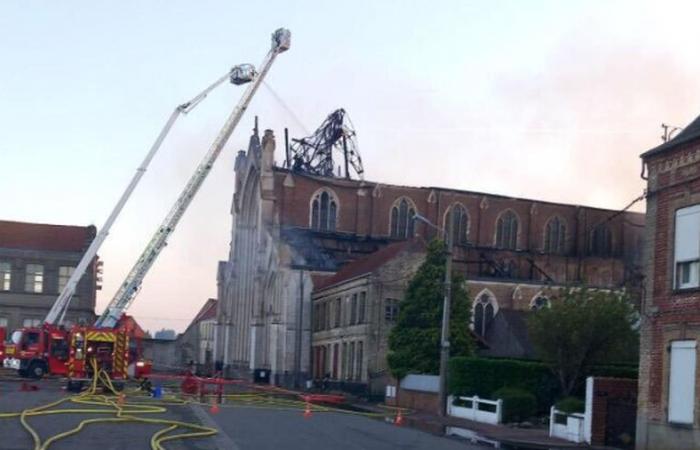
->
[0,0,700,331]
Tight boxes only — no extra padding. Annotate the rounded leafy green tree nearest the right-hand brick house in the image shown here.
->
[527,288,639,396]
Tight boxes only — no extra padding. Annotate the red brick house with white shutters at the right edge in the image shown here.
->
[637,117,700,449]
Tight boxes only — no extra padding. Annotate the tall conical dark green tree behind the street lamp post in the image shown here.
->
[387,240,472,379]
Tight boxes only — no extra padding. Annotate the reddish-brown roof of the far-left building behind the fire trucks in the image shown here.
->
[0,220,96,252]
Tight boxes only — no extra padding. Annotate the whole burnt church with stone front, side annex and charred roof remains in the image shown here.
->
[214,115,644,386]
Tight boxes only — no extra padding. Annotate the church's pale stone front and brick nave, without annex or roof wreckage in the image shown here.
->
[215,120,643,383]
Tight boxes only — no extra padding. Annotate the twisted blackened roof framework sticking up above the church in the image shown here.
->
[287,108,364,179]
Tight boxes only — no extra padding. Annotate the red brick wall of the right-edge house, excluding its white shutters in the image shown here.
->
[637,120,700,449]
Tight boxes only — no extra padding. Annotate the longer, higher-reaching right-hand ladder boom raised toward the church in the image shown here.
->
[95,29,290,328]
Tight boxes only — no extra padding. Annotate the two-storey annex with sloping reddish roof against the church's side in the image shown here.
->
[311,239,425,394]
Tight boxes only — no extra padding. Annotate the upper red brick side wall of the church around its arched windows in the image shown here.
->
[274,169,643,287]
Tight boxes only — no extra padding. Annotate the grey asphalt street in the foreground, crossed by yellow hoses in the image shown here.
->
[0,380,483,450]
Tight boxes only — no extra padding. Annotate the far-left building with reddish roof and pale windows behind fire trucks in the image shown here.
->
[0,221,98,330]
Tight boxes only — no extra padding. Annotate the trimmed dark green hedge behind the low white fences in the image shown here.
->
[448,357,637,412]
